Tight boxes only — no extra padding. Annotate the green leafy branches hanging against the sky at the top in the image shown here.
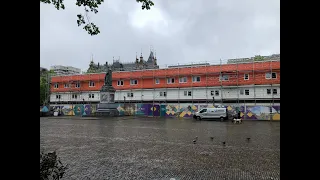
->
[40,0,154,36]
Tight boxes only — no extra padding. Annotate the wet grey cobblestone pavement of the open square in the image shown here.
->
[40,117,280,180]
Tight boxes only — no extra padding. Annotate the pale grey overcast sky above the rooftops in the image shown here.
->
[40,0,280,71]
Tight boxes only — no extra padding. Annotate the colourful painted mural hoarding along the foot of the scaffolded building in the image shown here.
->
[47,103,280,120]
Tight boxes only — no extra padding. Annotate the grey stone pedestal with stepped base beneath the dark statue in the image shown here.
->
[95,85,119,117]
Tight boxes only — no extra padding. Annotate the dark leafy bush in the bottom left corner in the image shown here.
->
[40,151,68,180]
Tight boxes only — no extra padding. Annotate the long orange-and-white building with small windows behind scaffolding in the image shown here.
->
[50,61,280,104]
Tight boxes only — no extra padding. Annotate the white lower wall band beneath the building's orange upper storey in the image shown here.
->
[50,85,280,102]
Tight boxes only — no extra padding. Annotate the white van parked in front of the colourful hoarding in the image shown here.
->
[193,108,228,121]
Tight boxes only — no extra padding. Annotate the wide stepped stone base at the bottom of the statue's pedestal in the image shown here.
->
[95,103,119,117]
